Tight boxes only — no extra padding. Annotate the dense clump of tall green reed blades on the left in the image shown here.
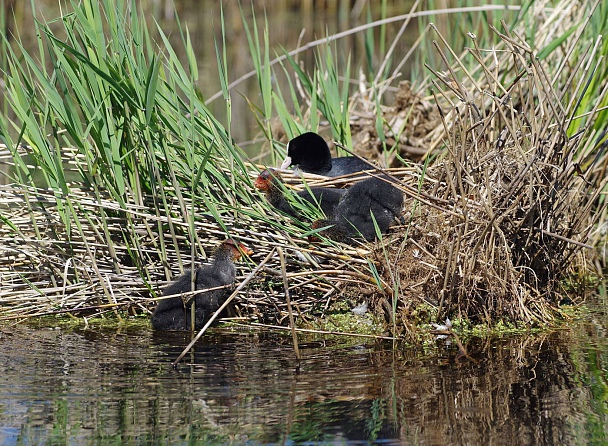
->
[2,0,250,296]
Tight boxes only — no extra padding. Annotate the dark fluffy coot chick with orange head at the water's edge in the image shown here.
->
[152,239,252,330]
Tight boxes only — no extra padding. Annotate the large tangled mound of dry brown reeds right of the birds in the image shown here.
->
[338,24,606,331]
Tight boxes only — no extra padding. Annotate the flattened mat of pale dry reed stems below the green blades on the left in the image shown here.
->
[0,164,416,323]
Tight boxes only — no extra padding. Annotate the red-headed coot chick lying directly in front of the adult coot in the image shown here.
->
[254,169,346,218]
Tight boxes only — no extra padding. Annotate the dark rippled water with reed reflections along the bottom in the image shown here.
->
[0,322,608,445]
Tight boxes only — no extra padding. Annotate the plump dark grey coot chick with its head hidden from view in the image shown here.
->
[313,178,403,242]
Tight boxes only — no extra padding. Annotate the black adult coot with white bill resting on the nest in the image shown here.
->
[281,132,374,177]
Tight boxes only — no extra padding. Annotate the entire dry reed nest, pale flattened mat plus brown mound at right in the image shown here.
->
[0,11,606,335]
